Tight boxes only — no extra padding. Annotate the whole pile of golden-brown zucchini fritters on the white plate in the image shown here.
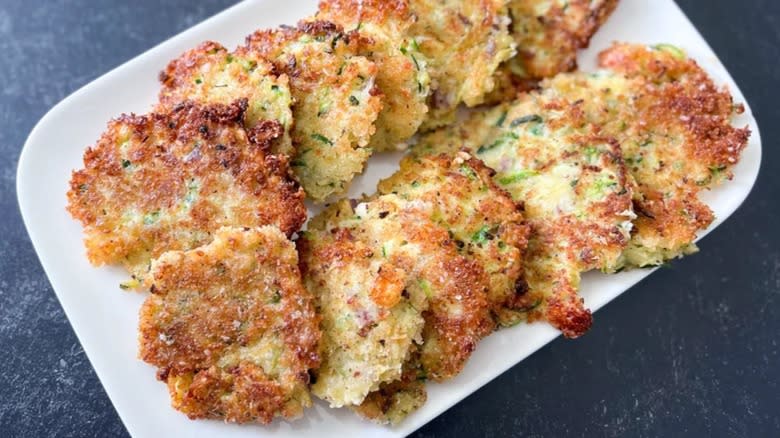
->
[68,0,749,424]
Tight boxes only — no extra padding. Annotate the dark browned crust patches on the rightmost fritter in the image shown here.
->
[599,44,750,256]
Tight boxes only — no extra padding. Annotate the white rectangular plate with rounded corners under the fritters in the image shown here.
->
[17,0,761,438]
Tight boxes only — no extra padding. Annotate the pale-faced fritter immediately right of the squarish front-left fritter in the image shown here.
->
[297,201,427,407]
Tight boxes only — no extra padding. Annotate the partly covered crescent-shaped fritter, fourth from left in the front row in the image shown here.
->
[378,152,530,325]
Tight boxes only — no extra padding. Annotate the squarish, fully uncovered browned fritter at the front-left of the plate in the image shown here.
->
[139,226,320,423]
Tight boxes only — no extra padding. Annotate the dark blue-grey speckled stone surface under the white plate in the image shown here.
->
[0,0,780,437]
